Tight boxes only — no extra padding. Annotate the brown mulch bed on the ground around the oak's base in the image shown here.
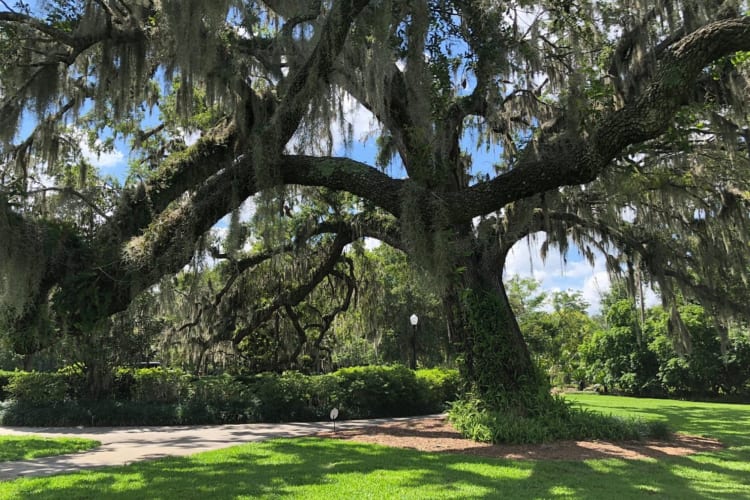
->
[317,417,722,460]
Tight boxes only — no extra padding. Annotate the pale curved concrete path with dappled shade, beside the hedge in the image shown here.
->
[0,417,434,481]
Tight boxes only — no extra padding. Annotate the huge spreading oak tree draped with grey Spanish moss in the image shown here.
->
[0,0,750,411]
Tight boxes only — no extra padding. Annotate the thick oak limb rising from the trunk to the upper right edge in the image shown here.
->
[445,17,750,220]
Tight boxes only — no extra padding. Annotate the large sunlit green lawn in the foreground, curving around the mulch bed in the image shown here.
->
[0,395,750,500]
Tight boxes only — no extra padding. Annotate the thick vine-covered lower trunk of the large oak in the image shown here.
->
[454,246,550,415]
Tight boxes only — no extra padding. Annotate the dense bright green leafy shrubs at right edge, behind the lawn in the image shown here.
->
[581,294,750,398]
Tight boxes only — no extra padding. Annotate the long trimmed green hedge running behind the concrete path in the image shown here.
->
[0,366,459,426]
